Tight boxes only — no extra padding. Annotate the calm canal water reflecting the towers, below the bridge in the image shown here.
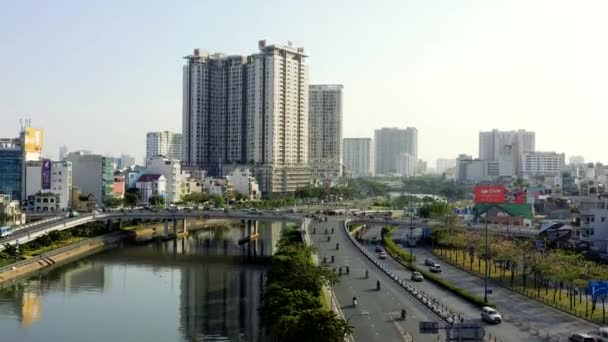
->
[0,223,283,342]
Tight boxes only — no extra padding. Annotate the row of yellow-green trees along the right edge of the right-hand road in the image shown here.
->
[432,228,608,320]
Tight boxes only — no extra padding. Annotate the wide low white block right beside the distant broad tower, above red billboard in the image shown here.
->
[520,151,566,178]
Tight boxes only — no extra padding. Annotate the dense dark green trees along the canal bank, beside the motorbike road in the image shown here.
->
[261,227,352,342]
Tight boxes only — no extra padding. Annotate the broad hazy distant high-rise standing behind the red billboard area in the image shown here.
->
[479,129,536,176]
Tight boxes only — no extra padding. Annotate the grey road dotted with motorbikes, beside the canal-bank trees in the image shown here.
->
[310,219,439,342]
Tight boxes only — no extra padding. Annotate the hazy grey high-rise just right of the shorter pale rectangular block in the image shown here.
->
[374,127,418,175]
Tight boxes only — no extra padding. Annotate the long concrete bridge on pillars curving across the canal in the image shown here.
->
[0,210,301,251]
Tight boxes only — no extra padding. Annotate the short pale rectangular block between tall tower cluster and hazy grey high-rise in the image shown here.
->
[343,138,374,178]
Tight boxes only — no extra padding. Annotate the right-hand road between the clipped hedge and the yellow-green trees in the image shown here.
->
[384,227,598,341]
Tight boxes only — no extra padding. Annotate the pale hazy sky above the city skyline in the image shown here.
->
[0,0,608,166]
